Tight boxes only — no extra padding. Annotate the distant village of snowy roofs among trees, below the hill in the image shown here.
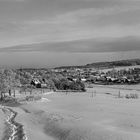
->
[52,68,140,84]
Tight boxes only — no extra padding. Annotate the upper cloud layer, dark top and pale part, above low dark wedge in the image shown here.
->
[0,0,140,47]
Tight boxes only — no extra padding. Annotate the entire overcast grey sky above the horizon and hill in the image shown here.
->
[0,0,140,67]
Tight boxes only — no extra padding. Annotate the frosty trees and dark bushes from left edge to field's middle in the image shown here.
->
[0,69,85,100]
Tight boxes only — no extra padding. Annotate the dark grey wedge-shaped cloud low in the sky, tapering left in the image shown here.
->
[0,36,140,53]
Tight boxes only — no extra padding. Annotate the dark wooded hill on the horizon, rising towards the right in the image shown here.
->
[56,59,140,69]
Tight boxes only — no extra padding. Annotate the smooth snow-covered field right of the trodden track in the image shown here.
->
[0,86,140,140]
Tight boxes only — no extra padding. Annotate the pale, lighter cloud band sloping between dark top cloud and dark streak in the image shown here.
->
[0,3,140,46]
